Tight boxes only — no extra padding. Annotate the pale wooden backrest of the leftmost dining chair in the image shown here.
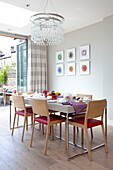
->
[12,96,26,110]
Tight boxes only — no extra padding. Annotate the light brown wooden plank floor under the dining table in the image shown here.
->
[0,103,113,170]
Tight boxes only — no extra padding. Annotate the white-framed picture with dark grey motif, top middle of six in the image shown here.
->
[67,48,75,62]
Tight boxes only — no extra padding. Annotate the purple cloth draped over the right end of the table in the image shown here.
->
[62,100,87,114]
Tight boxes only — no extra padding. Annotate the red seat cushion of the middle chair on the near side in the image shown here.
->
[34,115,65,125]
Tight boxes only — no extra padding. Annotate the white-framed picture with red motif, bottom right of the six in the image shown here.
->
[80,61,89,75]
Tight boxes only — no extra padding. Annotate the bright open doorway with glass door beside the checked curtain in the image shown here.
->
[0,34,28,91]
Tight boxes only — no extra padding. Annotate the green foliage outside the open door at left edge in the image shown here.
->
[0,66,9,85]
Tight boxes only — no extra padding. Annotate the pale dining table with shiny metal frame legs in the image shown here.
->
[10,97,107,160]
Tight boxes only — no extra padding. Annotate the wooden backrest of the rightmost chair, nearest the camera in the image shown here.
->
[86,99,107,119]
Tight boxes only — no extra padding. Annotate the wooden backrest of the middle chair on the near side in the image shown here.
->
[31,99,49,117]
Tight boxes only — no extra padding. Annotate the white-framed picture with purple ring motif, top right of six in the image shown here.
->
[80,44,89,60]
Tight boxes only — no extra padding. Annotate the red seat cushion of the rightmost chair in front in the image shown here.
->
[70,117,103,128]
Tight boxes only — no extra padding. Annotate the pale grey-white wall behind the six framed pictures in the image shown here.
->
[48,16,113,124]
